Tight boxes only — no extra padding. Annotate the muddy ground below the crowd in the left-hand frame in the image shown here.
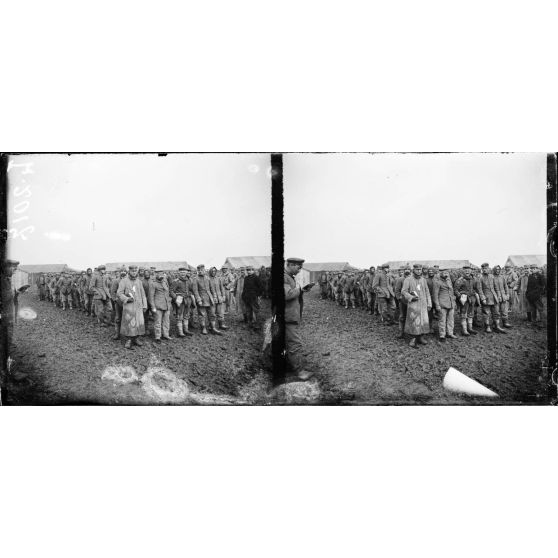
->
[5,292,270,405]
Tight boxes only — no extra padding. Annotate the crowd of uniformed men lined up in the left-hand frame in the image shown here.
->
[37,265,271,349]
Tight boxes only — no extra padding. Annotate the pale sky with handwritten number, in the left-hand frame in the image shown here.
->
[8,154,271,269]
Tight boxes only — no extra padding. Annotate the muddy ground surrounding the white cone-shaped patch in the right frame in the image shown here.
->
[303,289,547,405]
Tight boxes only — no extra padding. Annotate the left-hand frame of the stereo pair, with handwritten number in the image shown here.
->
[2,153,271,405]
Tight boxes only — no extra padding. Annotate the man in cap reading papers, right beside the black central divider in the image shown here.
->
[283,258,313,380]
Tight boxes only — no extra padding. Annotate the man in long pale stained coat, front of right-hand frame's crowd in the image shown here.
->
[401,264,432,349]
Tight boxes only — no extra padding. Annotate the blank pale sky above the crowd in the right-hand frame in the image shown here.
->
[283,154,546,267]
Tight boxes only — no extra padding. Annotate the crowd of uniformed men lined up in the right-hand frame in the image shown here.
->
[319,263,546,347]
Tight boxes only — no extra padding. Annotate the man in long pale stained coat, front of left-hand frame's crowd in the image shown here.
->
[116,265,147,350]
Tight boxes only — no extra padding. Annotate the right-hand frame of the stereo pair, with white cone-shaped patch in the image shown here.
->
[282,153,556,405]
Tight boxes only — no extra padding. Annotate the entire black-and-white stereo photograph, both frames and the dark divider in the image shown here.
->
[2,153,555,405]
